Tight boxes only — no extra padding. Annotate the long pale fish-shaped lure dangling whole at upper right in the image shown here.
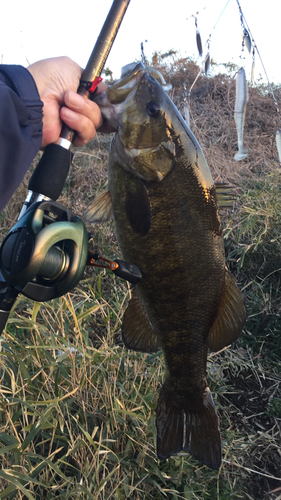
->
[234,68,249,161]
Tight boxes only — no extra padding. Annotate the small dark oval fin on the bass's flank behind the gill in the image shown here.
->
[125,179,151,236]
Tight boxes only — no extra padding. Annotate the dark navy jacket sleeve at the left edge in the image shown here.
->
[0,65,43,210]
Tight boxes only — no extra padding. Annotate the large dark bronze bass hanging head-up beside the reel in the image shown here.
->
[85,64,246,470]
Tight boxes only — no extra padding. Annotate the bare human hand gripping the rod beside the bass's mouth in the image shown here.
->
[27,57,113,148]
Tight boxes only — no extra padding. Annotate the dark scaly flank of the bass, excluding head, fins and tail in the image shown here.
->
[109,141,225,360]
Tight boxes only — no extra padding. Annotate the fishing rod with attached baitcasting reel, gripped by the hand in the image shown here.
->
[0,0,141,333]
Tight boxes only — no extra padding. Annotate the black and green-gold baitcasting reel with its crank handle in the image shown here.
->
[0,201,141,332]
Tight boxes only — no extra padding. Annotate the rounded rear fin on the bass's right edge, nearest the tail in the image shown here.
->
[208,271,246,351]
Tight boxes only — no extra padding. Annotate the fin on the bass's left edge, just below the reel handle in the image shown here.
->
[122,291,161,352]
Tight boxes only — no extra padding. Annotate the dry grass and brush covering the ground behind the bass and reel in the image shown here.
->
[0,54,281,500]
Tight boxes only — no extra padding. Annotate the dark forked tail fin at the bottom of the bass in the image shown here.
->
[156,384,221,470]
